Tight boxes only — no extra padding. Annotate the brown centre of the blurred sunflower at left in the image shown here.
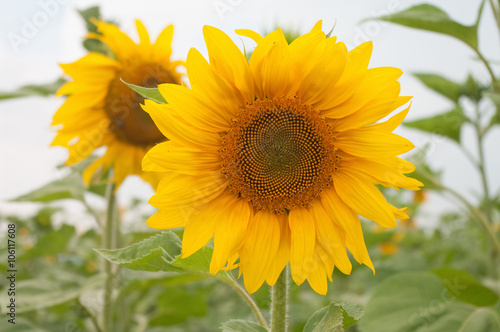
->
[104,64,179,146]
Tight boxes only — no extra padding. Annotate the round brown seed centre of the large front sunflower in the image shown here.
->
[221,98,337,213]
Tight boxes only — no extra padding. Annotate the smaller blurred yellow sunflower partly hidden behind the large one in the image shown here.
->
[51,21,181,187]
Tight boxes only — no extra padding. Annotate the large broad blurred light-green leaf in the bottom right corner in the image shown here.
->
[358,272,500,332]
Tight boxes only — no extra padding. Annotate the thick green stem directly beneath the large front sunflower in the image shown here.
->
[271,265,290,332]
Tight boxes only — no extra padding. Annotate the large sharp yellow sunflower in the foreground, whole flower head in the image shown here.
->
[143,21,422,294]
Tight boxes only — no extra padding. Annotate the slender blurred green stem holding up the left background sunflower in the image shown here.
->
[102,178,116,332]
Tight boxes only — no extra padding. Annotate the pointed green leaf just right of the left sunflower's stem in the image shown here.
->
[95,232,182,271]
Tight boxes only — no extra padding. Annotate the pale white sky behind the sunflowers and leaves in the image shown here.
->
[0,0,500,230]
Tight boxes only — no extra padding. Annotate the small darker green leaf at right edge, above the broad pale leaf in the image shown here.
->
[430,268,498,307]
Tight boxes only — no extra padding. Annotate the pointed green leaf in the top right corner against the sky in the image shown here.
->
[376,2,484,49]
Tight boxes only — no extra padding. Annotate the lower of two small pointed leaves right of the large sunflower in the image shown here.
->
[403,105,467,142]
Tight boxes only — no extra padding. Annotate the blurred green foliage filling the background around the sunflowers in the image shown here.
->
[0,0,500,332]
